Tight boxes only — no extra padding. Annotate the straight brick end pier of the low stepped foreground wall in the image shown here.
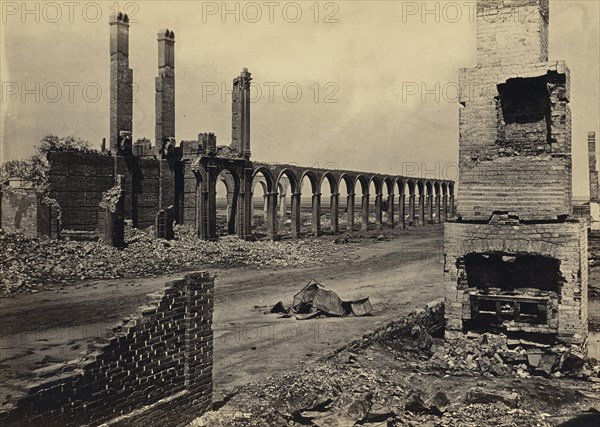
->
[184,271,214,413]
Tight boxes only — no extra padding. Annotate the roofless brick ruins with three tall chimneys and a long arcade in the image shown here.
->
[2,13,455,242]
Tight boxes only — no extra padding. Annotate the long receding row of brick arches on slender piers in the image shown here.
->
[207,163,454,238]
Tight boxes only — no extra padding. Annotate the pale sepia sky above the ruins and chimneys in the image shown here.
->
[0,0,600,196]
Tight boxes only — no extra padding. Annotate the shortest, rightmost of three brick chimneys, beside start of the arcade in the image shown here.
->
[231,68,252,159]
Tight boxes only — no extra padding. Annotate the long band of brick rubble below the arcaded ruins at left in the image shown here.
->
[0,226,349,295]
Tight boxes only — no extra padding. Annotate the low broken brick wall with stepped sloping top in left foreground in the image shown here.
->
[0,272,214,427]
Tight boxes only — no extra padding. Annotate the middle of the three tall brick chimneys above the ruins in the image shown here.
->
[155,29,175,152]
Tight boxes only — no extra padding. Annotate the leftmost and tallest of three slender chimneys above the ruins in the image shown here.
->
[110,12,133,154]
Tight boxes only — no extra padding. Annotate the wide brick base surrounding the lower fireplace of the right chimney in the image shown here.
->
[444,220,588,345]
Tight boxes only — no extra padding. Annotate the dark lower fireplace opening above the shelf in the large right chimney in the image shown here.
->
[465,253,560,293]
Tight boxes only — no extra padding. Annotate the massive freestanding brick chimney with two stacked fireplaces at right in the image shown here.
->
[444,0,588,348]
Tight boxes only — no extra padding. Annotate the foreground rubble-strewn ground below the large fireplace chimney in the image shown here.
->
[191,301,600,427]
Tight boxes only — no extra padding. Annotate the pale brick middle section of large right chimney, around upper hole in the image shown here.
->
[457,61,572,221]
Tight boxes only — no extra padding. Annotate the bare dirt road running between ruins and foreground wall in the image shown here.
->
[0,226,443,399]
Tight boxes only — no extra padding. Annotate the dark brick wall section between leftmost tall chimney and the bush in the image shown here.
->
[48,152,114,231]
